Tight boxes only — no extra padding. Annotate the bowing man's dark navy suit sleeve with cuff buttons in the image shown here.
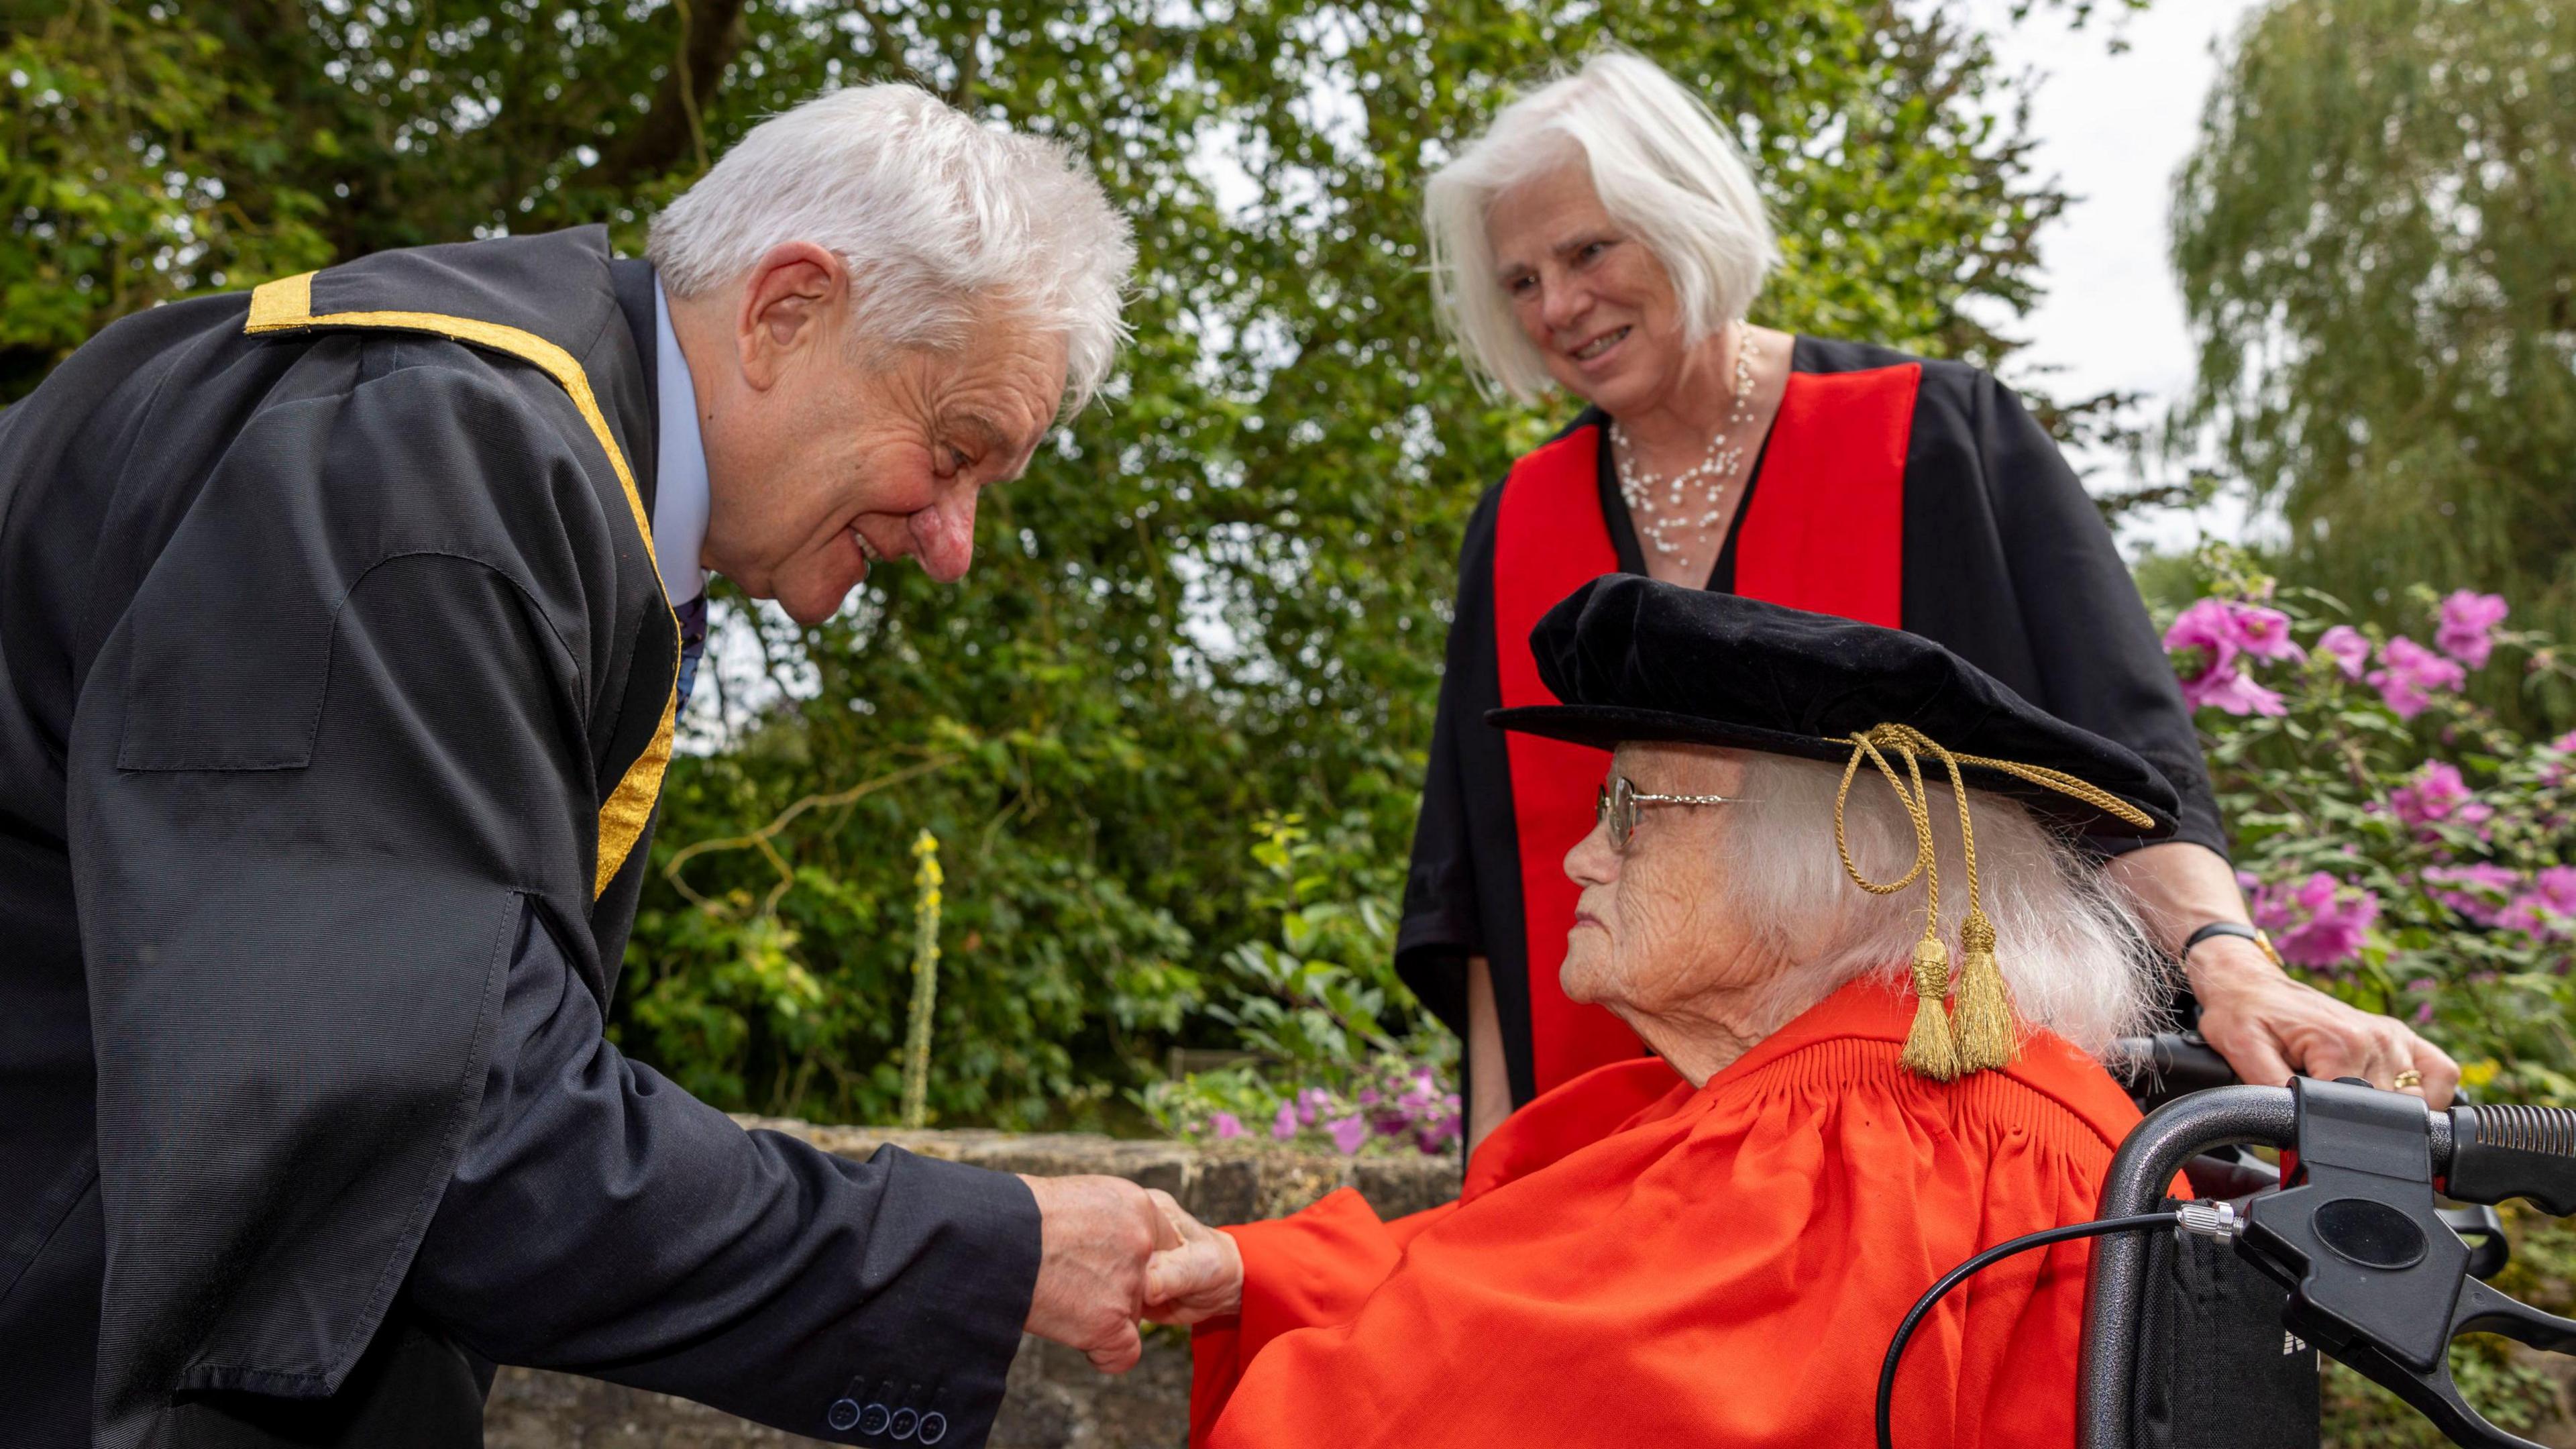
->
[410,910,1038,1449]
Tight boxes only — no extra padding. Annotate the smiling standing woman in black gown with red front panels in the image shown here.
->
[1396,49,2457,1140]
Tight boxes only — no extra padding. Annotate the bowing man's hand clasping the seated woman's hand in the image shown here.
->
[1020,1176,1180,1375]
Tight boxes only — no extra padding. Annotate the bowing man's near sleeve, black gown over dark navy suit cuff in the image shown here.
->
[67,353,1038,1444]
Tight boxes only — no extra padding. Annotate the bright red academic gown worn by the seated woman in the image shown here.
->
[1190,982,2138,1449]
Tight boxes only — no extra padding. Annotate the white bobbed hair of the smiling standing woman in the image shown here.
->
[1422,46,1780,402]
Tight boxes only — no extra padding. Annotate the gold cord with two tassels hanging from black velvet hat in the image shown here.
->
[1834,724,2156,1083]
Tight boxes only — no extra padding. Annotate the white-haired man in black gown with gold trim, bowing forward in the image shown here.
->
[0,85,1165,1449]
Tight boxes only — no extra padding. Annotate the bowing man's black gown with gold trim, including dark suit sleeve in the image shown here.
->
[0,227,1038,1449]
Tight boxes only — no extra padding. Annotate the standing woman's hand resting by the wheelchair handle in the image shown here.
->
[2190,938,2460,1109]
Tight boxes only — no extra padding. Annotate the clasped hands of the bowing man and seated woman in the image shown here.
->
[1020,1178,1244,1375]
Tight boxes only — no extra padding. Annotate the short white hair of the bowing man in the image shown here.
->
[647,85,1136,410]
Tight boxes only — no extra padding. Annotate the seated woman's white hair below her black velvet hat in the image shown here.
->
[1718,753,2164,1057]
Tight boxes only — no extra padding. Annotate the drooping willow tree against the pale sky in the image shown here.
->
[2174,0,2576,670]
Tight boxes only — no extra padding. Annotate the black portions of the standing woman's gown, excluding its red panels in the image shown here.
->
[1396,337,2226,1106]
